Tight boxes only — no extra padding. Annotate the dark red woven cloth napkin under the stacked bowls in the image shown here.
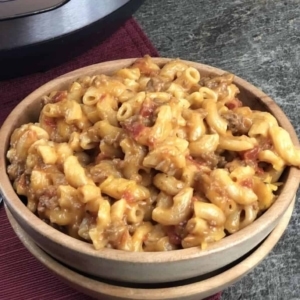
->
[0,19,221,300]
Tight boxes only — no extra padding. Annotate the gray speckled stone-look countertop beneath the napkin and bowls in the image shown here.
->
[135,0,300,300]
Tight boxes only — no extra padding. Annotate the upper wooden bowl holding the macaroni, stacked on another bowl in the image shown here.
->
[0,58,300,283]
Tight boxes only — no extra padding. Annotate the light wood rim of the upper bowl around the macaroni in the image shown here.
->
[0,58,300,264]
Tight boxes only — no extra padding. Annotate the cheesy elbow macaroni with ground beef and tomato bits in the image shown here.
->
[7,56,300,251]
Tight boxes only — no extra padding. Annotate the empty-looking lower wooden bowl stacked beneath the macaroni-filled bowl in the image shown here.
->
[6,197,295,300]
